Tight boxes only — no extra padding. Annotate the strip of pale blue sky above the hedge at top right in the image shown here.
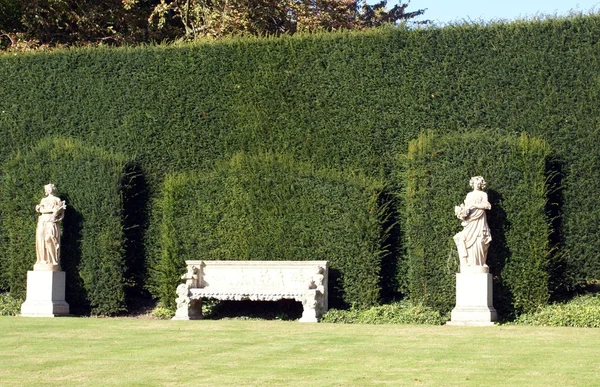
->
[410,0,600,24]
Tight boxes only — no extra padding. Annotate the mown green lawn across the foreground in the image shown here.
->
[0,317,600,386]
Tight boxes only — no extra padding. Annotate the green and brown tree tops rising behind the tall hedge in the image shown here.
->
[0,0,425,50]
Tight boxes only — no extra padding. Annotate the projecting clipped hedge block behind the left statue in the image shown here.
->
[0,138,134,314]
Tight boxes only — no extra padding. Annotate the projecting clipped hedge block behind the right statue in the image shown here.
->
[397,131,550,316]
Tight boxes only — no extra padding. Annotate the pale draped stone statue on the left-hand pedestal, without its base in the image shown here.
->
[35,184,67,267]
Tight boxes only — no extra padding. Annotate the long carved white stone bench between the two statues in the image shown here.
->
[173,260,328,322]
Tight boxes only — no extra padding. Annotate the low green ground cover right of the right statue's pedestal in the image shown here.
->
[514,294,600,328]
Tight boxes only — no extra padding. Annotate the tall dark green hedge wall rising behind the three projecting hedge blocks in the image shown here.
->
[0,15,600,310]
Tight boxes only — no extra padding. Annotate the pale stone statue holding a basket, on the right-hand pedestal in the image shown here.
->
[454,176,492,271]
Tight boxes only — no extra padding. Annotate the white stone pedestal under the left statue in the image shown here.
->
[21,266,69,317]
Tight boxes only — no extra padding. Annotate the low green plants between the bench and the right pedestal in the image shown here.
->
[321,301,446,325]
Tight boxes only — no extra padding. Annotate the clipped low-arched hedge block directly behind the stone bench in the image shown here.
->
[151,154,386,307]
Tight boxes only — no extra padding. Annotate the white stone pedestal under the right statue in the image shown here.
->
[446,266,497,326]
